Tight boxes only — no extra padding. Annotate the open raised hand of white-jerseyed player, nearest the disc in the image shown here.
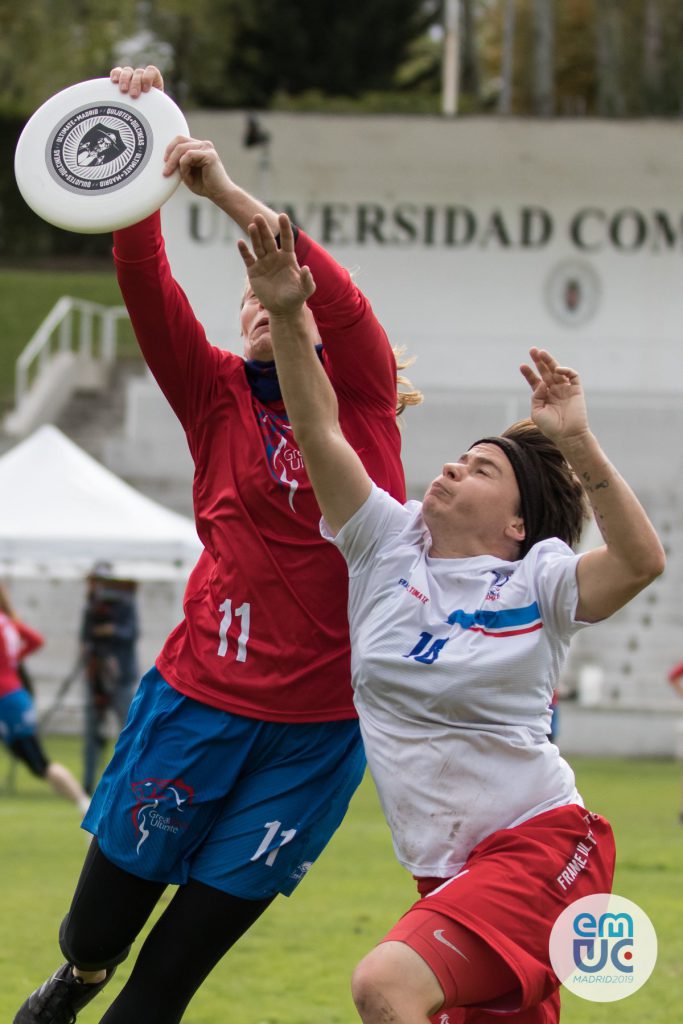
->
[238,213,315,315]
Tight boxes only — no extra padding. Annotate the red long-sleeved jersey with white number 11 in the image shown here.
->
[114,214,405,722]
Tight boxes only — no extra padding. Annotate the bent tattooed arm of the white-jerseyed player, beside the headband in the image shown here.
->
[520,348,666,622]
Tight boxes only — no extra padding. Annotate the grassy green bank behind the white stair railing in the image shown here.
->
[0,268,138,402]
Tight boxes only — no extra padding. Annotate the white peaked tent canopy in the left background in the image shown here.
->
[0,425,201,577]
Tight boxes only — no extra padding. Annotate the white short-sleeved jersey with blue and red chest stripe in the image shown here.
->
[321,485,583,878]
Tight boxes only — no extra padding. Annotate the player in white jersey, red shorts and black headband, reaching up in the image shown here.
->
[238,215,665,1024]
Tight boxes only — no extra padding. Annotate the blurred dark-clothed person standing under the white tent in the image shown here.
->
[81,561,139,794]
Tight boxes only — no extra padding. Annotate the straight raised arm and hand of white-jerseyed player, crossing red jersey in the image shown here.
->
[238,213,372,534]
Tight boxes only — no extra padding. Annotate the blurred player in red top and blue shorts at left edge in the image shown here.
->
[0,584,90,814]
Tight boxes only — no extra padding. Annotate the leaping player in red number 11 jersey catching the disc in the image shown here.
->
[14,66,421,1024]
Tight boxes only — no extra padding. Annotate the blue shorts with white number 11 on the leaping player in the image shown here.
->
[83,669,366,899]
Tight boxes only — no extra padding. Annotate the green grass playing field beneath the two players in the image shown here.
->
[0,737,683,1024]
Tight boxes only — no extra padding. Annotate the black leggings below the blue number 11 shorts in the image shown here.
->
[59,839,273,1024]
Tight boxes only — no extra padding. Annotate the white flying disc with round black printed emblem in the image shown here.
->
[14,78,188,234]
